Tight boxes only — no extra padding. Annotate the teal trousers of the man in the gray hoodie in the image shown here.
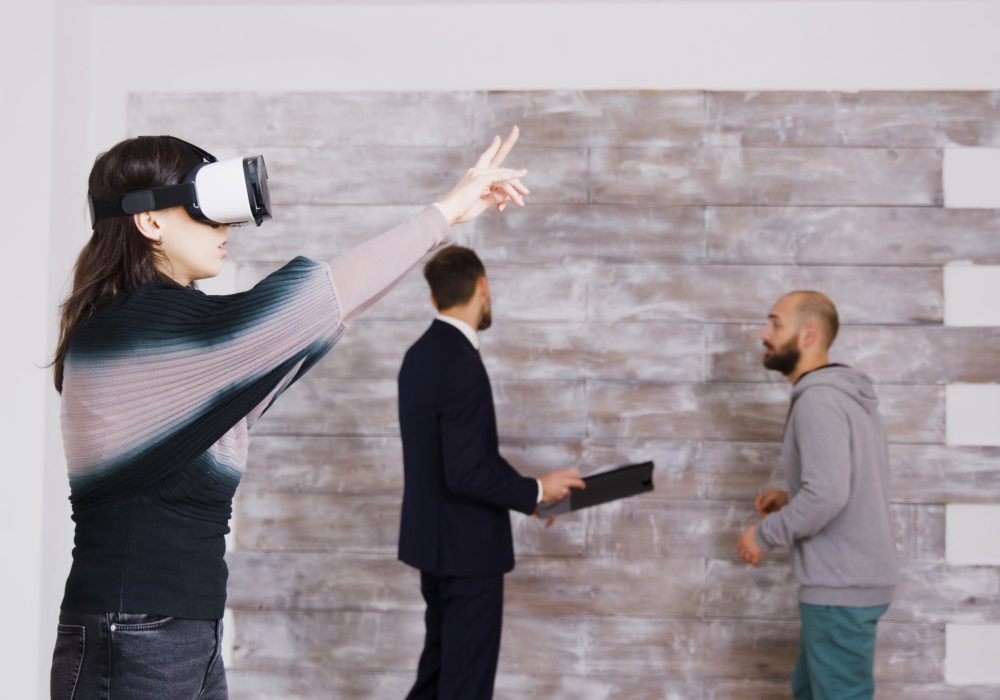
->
[792,603,889,700]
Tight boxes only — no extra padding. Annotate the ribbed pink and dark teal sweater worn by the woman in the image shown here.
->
[62,207,450,619]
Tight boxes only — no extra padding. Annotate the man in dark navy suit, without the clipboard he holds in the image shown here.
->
[399,246,584,700]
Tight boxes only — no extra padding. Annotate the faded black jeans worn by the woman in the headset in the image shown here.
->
[51,612,229,700]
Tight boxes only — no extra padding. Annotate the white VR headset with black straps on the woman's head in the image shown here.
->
[87,136,271,226]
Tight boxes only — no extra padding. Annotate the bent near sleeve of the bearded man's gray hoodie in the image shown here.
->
[757,386,851,550]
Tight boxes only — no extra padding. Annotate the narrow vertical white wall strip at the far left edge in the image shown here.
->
[0,0,54,698]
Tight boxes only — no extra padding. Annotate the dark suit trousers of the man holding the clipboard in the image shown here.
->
[406,572,503,700]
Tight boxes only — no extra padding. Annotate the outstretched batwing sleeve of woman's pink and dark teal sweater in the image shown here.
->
[62,208,448,496]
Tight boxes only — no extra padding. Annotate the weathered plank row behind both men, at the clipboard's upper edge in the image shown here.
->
[243,434,1000,504]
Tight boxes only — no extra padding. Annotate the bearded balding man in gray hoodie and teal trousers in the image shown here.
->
[738,291,898,700]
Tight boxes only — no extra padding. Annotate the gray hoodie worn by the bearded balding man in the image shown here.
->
[757,365,898,607]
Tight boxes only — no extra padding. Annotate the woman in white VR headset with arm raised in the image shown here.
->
[51,127,527,700]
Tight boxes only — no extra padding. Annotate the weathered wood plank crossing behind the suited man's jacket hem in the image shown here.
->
[227,552,705,618]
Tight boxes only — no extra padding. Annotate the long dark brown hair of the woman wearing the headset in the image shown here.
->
[52,136,202,392]
